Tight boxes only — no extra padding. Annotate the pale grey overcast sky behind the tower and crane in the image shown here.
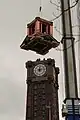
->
[0,0,77,120]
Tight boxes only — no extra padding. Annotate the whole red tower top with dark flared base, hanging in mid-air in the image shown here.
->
[20,17,59,55]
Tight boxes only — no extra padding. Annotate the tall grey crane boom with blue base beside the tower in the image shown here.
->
[61,0,80,120]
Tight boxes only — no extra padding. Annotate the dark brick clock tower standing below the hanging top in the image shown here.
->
[26,58,59,120]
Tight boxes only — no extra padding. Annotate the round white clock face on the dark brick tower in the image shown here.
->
[34,64,46,76]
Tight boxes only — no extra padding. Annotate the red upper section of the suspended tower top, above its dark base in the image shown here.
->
[27,17,53,36]
